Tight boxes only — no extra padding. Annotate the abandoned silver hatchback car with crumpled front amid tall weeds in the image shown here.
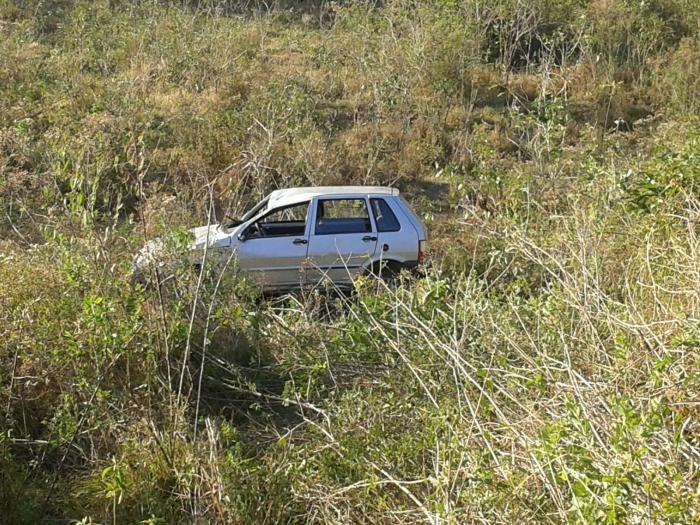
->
[135,186,428,292]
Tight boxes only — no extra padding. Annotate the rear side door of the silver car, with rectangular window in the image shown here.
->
[307,196,377,285]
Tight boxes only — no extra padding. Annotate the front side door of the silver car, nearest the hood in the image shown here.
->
[237,201,310,290]
